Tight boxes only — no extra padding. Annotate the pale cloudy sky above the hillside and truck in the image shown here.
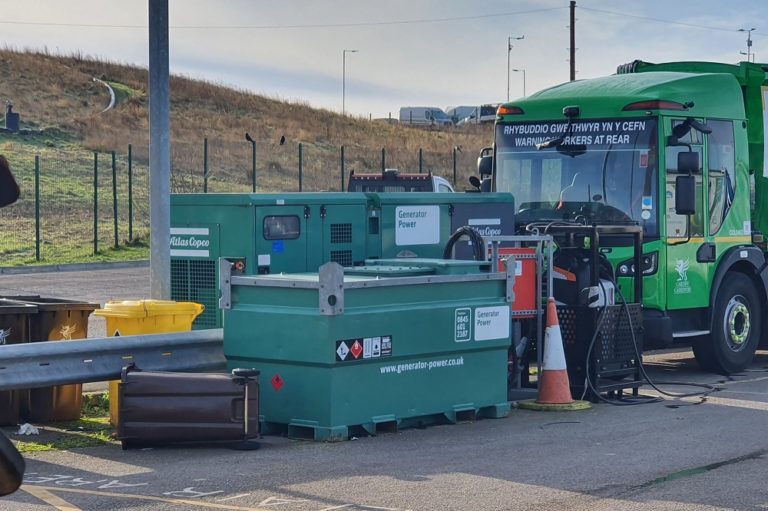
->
[0,0,768,117]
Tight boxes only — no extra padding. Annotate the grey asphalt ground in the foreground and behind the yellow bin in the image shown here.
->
[0,268,768,511]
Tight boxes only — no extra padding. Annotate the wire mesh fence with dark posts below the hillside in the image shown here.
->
[0,140,476,266]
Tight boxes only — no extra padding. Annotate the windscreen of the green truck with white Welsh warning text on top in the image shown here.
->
[494,118,659,238]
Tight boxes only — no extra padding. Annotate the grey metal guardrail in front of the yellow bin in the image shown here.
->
[0,328,226,390]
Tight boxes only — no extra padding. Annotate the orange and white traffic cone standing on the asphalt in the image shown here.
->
[518,297,591,411]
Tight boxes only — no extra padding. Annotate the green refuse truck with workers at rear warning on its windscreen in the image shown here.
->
[478,61,768,374]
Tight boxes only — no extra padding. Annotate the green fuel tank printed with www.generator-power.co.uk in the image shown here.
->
[220,259,514,440]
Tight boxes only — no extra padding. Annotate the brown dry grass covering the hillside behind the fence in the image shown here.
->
[0,48,492,191]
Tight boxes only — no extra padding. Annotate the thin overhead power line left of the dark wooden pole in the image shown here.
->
[0,7,566,30]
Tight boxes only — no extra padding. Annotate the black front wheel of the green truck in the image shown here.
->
[693,273,762,374]
